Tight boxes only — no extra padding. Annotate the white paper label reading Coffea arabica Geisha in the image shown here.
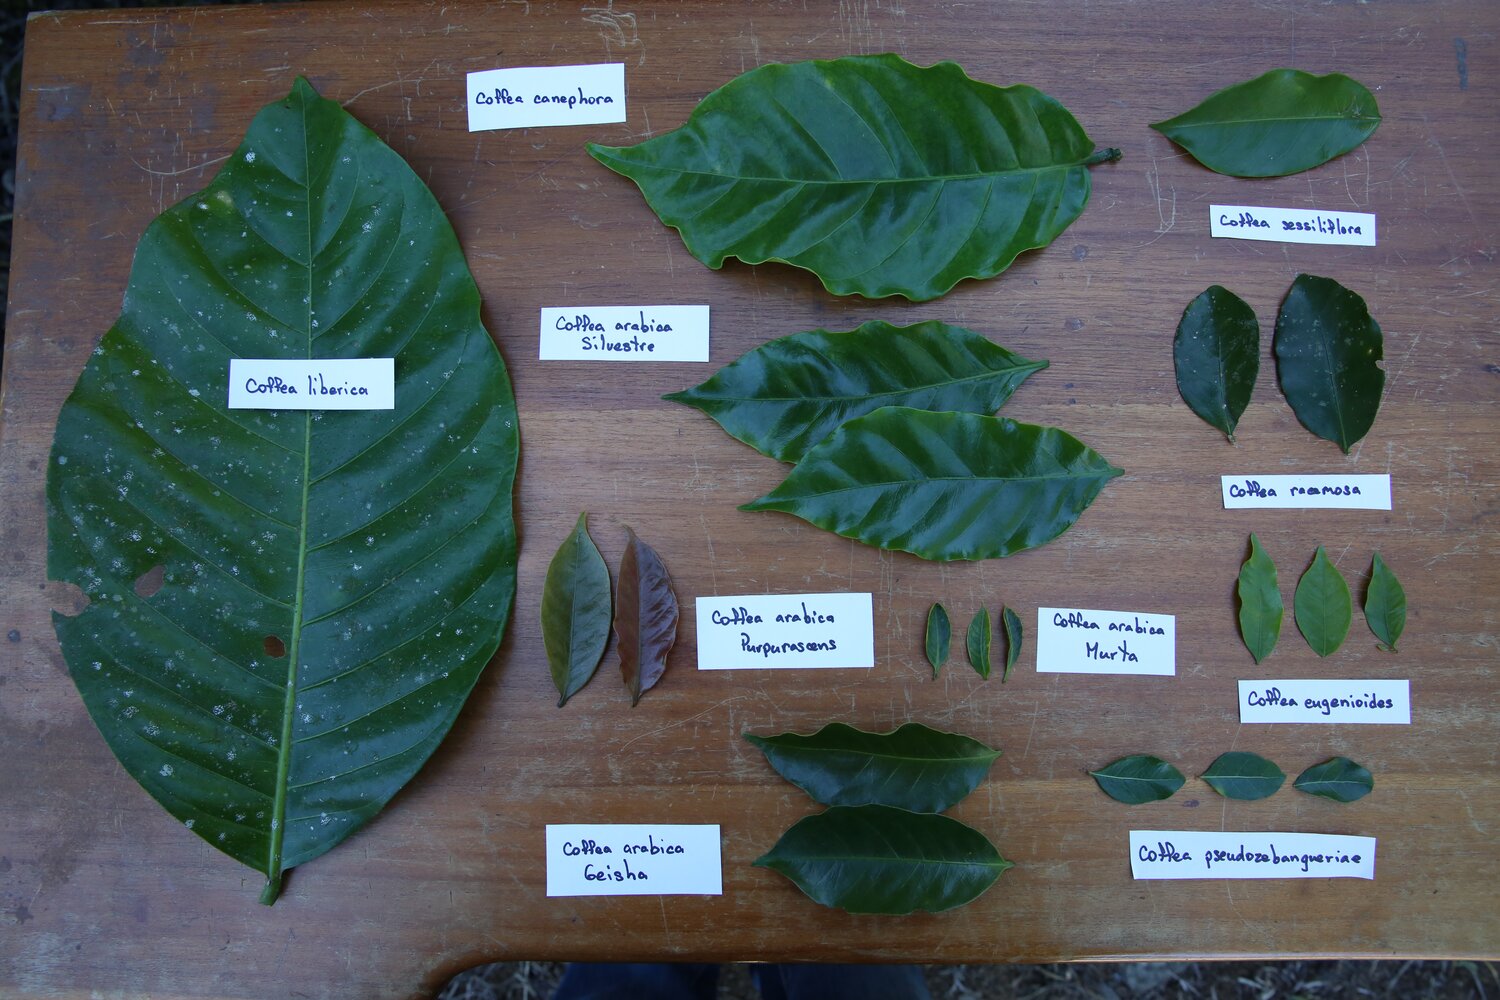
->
[548,823,725,897]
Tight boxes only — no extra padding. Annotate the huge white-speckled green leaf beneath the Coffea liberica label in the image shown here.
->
[47,79,518,903]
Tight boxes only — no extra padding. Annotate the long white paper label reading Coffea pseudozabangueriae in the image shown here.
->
[1130,831,1376,879]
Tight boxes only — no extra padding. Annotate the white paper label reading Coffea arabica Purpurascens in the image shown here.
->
[696,594,875,670]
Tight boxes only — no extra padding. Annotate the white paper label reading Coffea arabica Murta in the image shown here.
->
[1037,607,1178,676]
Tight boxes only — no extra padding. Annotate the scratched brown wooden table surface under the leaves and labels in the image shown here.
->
[0,0,1500,997]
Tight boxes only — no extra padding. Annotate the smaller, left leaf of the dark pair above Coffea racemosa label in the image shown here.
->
[1172,285,1260,441]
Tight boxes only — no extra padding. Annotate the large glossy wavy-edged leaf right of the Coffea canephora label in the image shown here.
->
[588,54,1119,301]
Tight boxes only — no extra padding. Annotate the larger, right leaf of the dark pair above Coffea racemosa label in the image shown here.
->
[1272,274,1386,454]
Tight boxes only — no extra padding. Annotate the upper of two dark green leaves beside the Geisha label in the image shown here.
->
[746,723,1001,813]
